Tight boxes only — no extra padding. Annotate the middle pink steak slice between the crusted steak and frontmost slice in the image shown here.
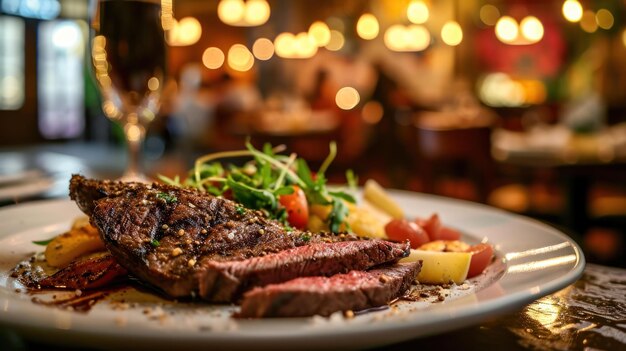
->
[198,240,409,302]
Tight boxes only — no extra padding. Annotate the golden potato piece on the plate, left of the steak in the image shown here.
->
[44,224,104,268]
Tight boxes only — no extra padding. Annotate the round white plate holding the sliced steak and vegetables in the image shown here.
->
[0,192,585,350]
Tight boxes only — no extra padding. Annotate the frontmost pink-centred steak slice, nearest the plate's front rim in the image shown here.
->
[239,261,422,318]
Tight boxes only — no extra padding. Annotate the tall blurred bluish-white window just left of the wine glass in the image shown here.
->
[38,20,86,139]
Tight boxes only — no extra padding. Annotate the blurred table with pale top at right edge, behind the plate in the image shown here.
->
[492,125,626,242]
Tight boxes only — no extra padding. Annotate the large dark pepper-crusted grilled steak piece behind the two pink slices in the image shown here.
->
[70,175,409,301]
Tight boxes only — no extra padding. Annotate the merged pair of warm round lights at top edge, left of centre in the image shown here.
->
[217,0,271,27]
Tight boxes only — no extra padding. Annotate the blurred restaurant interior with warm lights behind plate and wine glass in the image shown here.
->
[0,0,626,266]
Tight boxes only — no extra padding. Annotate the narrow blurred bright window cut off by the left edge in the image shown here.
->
[0,16,24,110]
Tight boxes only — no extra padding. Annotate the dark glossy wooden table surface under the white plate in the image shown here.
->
[0,264,626,351]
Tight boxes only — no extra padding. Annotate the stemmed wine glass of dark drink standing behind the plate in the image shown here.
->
[90,0,166,182]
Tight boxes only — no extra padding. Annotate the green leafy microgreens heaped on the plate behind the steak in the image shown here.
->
[159,142,356,232]
